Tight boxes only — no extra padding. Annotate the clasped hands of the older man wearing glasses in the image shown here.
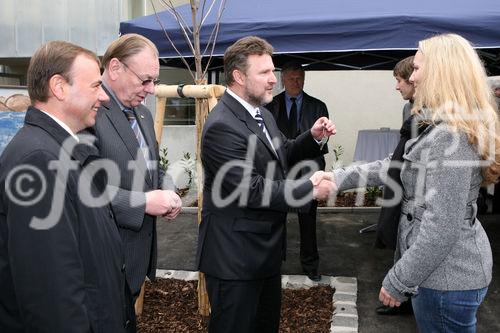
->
[146,190,182,219]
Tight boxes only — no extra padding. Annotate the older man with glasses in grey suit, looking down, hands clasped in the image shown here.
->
[95,34,181,297]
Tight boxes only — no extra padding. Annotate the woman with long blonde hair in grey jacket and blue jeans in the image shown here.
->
[334,34,500,332]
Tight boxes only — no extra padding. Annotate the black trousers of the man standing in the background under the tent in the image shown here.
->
[298,200,319,273]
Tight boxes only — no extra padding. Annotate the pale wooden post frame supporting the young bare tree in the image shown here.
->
[135,81,226,316]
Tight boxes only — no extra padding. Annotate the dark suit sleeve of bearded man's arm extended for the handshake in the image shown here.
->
[202,122,312,211]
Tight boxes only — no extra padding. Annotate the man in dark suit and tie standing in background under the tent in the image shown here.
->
[266,62,328,282]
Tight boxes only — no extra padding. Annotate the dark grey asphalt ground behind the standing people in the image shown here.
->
[158,211,500,333]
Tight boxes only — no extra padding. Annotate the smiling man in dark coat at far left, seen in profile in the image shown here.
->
[0,41,129,333]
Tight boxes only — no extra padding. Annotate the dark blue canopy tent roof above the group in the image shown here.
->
[120,0,500,74]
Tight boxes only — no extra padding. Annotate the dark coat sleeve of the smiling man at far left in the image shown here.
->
[4,152,90,332]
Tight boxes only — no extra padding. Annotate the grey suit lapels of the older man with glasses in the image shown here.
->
[102,86,155,186]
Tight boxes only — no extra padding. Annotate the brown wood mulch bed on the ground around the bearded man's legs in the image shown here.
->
[137,279,334,333]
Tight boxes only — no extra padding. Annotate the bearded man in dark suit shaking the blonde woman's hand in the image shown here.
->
[197,37,335,333]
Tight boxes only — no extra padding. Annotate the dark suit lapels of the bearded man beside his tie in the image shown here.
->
[221,92,283,164]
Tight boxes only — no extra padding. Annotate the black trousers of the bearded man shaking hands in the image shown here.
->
[205,275,281,333]
